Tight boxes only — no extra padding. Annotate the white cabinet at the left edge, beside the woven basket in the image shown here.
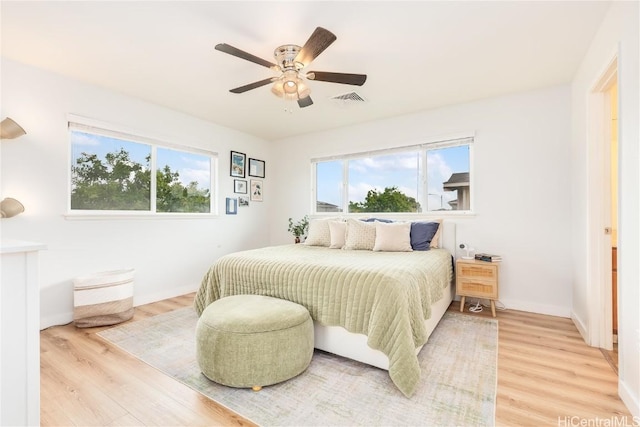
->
[0,239,45,426]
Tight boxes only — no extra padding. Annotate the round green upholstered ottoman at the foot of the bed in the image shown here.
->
[196,295,313,391]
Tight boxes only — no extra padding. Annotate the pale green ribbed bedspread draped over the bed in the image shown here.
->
[194,244,453,396]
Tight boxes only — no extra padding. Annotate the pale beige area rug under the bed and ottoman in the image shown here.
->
[99,307,498,426]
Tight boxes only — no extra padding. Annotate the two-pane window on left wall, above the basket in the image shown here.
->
[69,122,217,214]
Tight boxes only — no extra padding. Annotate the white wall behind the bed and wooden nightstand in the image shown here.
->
[270,86,571,317]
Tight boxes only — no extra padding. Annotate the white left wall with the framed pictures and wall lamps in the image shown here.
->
[0,60,271,327]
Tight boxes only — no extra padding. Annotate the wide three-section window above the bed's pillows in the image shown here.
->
[312,138,473,213]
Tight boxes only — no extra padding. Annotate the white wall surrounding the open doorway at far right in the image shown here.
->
[571,2,640,416]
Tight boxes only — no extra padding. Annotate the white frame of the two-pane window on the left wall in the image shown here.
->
[64,114,220,219]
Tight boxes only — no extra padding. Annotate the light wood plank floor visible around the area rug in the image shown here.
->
[40,294,631,426]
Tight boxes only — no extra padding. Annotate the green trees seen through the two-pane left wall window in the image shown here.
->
[71,148,211,212]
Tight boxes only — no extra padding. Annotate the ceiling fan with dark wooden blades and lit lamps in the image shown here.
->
[216,27,367,108]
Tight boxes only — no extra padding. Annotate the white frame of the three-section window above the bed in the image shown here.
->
[310,132,475,218]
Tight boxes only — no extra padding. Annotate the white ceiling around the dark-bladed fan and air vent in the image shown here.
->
[0,1,609,140]
